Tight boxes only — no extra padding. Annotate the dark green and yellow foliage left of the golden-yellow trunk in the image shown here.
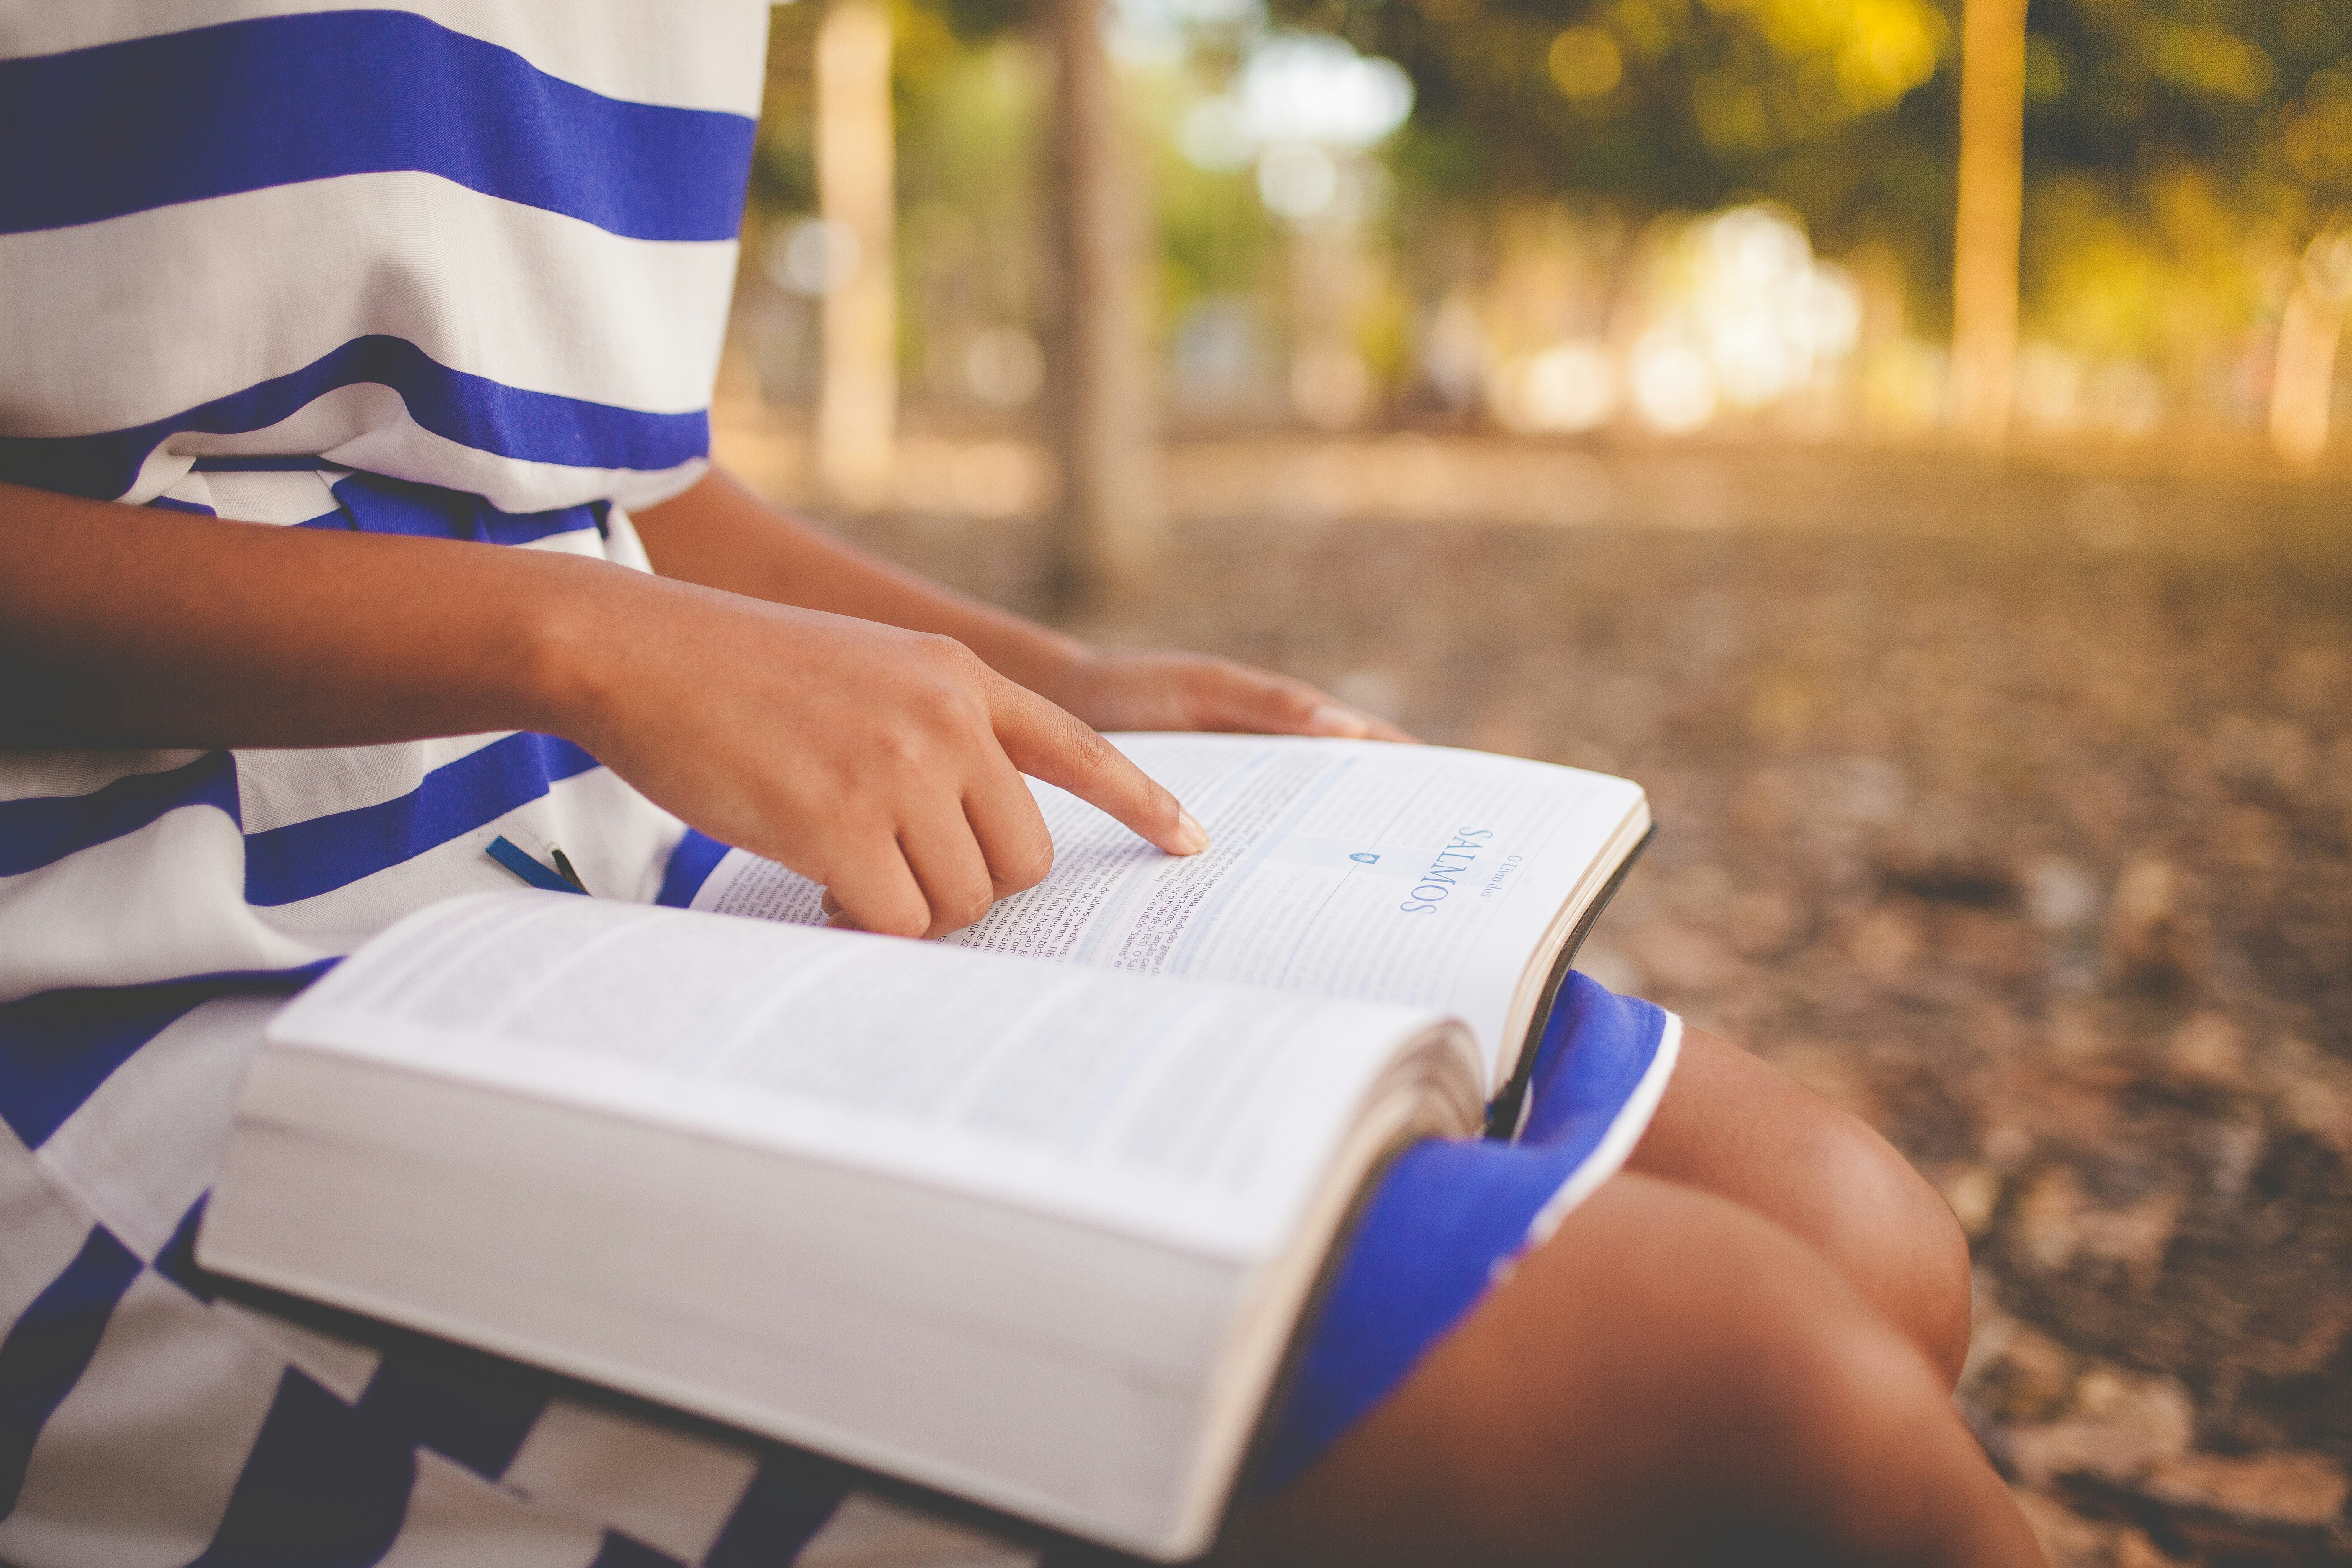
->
[1289,0,1957,275]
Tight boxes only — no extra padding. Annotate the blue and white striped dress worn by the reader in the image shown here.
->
[0,0,1679,1568]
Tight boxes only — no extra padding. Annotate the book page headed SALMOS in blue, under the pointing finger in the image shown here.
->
[694,733,1642,1070]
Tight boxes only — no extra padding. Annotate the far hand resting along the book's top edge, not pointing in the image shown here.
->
[1039,649,1413,740]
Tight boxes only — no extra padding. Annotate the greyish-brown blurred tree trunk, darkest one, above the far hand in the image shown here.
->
[1044,0,1160,602]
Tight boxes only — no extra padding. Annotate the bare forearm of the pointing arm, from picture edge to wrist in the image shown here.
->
[0,484,607,748]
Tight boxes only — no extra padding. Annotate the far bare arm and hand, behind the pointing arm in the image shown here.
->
[635,470,1411,740]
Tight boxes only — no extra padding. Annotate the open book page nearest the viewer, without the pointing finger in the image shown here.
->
[271,893,1470,1253]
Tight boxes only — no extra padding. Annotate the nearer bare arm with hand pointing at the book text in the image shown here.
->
[0,484,1207,936]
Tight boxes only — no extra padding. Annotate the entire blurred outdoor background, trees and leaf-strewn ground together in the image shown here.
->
[713,0,2352,1568]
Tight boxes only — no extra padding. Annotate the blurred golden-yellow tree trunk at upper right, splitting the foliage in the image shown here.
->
[1952,0,2025,451]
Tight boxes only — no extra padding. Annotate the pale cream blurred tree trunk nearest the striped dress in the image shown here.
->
[816,0,898,510]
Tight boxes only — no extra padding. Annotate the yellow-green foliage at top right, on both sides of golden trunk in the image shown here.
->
[1277,0,2352,334]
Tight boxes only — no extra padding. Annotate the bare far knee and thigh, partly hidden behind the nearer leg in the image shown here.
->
[1627,1030,1969,1389]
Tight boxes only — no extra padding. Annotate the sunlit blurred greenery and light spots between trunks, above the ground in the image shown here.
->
[729,0,2352,515]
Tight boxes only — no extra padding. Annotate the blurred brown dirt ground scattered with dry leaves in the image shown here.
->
[776,449,2352,1565]
